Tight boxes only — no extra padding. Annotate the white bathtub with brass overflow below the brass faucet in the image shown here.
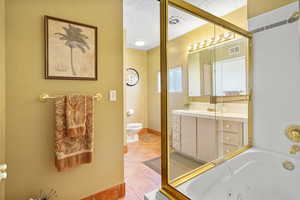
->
[177,148,300,200]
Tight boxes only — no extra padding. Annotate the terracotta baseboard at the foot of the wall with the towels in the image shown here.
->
[81,183,125,200]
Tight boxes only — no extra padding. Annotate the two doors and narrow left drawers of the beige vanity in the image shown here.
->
[172,115,218,162]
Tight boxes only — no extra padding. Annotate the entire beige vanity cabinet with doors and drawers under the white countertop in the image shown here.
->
[172,114,245,162]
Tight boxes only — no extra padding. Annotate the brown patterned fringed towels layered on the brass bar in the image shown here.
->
[55,95,94,171]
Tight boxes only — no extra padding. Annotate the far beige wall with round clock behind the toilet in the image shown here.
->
[125,49,148,128]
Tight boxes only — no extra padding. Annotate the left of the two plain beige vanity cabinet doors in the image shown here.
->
[181,116,197,158]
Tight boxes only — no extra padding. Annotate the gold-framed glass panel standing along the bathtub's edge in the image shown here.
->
[161,0,252,199]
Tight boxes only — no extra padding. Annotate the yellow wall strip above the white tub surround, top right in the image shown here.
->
[248,0,296,18]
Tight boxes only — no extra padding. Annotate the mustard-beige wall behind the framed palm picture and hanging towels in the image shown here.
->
[5,0,124,200]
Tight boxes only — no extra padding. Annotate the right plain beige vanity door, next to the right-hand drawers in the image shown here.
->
[197,118,218,162]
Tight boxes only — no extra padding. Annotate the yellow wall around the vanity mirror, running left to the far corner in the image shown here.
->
[148,7,247,130]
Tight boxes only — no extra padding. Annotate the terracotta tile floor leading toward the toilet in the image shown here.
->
[123,133,161,200]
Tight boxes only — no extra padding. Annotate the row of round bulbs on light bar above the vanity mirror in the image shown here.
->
[188,32,235,53]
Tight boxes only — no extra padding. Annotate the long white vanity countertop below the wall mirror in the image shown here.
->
[172,110,248,121]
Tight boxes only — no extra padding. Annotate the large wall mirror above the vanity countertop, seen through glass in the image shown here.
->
[188,38,247,97]
